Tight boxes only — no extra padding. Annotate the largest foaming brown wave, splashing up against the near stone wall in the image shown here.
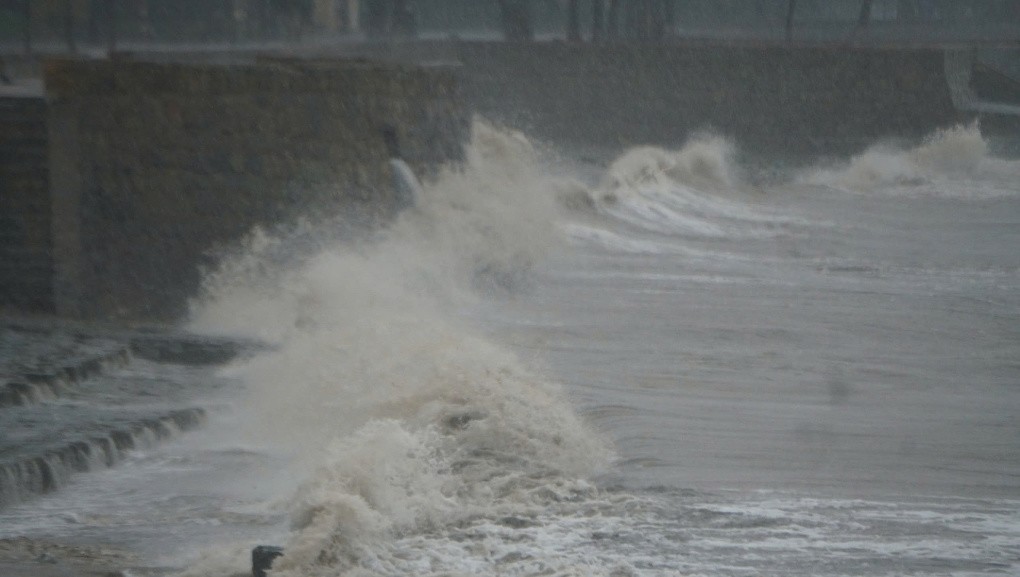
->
[185,119,610,575]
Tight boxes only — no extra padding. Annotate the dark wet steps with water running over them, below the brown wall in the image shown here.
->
[0,326,258,508]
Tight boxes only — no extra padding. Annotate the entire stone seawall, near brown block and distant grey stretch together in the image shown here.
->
[0,41,979,319]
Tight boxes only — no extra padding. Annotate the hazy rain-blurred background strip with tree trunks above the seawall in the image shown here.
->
[0,0,1020,54]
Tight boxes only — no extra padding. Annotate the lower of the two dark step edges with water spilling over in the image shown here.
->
[0,408,206,508]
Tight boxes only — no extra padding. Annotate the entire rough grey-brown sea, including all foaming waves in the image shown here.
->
[0,122,1020,576]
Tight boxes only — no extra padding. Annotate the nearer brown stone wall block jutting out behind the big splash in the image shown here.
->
[45,60,468,319]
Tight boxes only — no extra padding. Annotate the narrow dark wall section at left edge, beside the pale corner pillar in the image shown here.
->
[0,94,53,312]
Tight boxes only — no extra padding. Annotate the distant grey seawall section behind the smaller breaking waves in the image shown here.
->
[440,43,961,152]
